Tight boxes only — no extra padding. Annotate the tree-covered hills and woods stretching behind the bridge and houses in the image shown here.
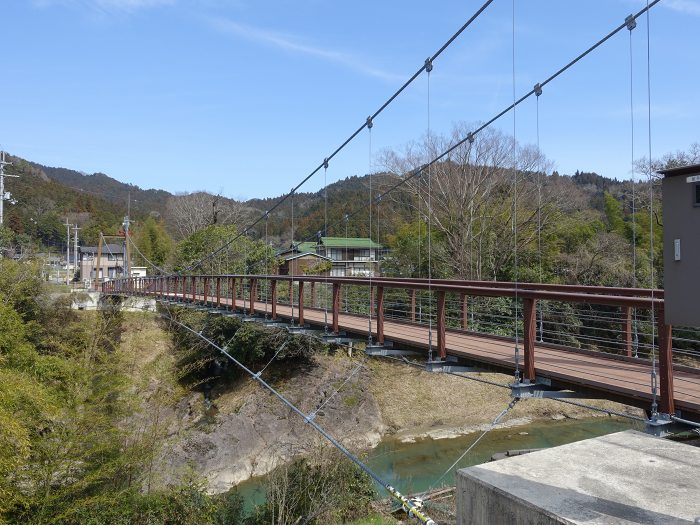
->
[0,137,700,286]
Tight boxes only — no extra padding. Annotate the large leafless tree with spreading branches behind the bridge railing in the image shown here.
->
[381,124,553,279]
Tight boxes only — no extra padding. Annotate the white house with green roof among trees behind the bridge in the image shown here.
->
[280,237,385,277]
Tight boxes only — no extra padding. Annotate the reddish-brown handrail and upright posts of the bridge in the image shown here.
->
[102,275,688,414]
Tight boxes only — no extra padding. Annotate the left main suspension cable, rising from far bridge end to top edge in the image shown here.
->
[179,0,493,273]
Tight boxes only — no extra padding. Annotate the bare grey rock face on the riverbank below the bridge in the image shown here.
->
[153,356,386,492]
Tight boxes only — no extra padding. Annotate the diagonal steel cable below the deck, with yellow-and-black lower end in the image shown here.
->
[163,315,437,525]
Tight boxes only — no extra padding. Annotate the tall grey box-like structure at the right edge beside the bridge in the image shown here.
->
[663,175,700,326]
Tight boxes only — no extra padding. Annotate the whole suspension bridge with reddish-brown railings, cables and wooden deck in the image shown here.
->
[97,0,700,524]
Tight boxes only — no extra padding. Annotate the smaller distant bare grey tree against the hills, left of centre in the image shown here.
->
[166,191,246,237]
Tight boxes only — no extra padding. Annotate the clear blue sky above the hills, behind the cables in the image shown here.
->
[0,0,700,198]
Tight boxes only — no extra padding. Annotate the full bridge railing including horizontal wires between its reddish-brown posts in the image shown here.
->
[103,275,700,420]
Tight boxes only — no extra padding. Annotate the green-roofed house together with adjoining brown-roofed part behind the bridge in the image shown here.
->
[278,237,385,277]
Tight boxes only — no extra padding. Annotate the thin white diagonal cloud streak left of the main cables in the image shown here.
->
[206,17,403,81]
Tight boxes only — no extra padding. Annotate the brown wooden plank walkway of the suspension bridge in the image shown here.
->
[234,299,700,419]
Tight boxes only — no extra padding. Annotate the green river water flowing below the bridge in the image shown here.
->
[238,417,641,509]
